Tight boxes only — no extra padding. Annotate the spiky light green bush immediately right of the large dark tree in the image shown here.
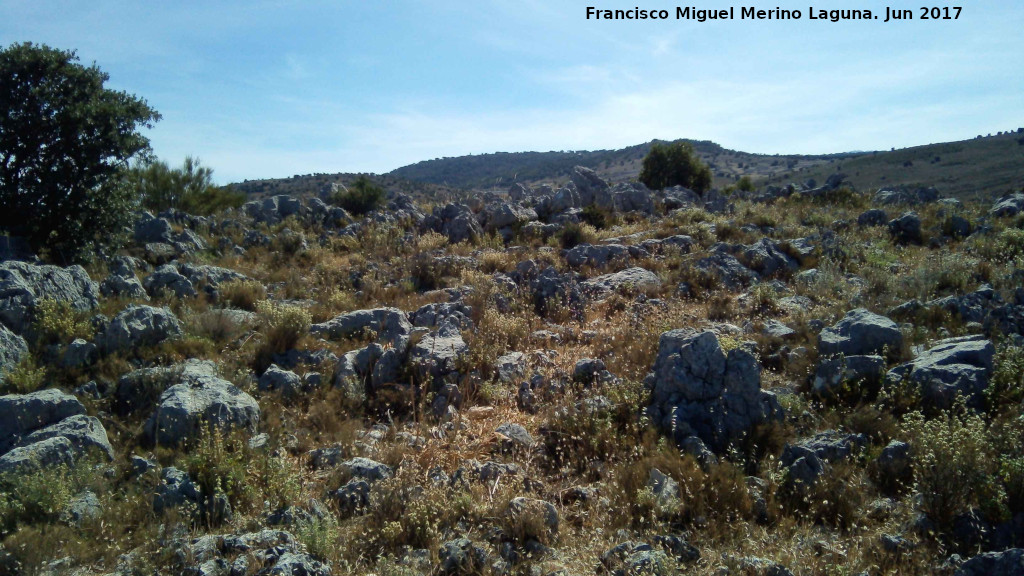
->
[131,156,246,215]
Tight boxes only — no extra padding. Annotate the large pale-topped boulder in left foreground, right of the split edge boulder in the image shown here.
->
[144,362,260,446]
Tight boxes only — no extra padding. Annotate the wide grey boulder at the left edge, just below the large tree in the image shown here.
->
[0,260,99,334]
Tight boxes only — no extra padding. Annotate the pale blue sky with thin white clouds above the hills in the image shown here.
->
[0,0,1024,183]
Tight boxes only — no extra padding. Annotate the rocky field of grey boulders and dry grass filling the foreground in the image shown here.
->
[0,163,1024,576]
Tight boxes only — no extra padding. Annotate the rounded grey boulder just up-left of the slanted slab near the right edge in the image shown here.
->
[818,308,903,357]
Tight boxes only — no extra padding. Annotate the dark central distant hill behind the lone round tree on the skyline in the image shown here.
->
[390,140,851,190]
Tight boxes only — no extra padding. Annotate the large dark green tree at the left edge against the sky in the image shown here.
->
[0,43,160,260]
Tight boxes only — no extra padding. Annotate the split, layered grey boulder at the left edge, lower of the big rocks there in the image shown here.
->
[0,389,114,474]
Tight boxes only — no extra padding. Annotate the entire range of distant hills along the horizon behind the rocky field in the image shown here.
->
[234,129,1024,202]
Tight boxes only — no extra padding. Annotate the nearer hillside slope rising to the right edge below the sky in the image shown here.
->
[767,129,1024,199]
